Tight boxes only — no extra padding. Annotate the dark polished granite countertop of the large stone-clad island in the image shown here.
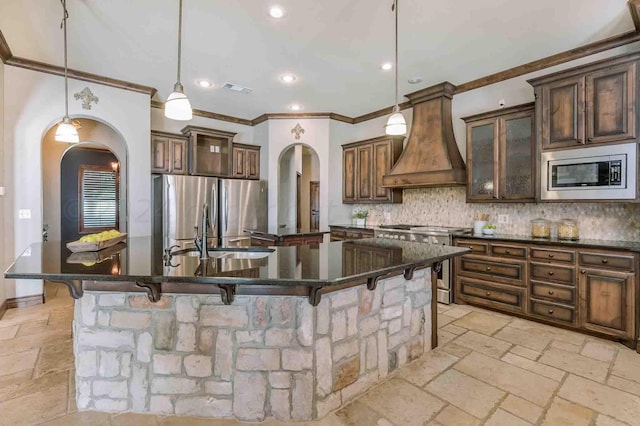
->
[5,237,469,292]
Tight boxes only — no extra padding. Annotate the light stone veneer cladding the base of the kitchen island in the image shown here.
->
[74,269,431,421]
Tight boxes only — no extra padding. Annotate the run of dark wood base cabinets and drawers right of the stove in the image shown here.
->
[454,238,639,347]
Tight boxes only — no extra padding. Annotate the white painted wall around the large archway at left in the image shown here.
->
[3,66,151,298]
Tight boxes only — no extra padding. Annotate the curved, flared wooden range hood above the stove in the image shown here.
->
[382,82,467,188]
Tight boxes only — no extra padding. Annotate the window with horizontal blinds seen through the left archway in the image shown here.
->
[78,165,120,233]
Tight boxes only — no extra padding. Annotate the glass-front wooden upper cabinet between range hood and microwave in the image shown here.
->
[463,103,536,202]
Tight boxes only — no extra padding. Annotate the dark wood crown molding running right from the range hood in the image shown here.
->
[455,31,640,95]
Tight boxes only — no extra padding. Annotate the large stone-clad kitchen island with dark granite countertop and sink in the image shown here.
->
[5,238,469,421]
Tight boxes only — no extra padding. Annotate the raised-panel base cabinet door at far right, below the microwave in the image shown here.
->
[580,269,635,339]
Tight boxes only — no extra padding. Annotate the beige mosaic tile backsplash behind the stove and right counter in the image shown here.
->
[354,187,640,241]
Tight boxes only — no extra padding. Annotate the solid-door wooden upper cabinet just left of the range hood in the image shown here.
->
[342,136,404,203]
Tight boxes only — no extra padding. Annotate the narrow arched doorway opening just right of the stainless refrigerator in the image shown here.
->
[278,144,320,230]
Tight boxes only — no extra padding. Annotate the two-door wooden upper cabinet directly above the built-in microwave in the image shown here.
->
[529,55,638,151]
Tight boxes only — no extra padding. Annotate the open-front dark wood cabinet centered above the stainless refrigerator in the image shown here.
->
[182,126,236,177]
